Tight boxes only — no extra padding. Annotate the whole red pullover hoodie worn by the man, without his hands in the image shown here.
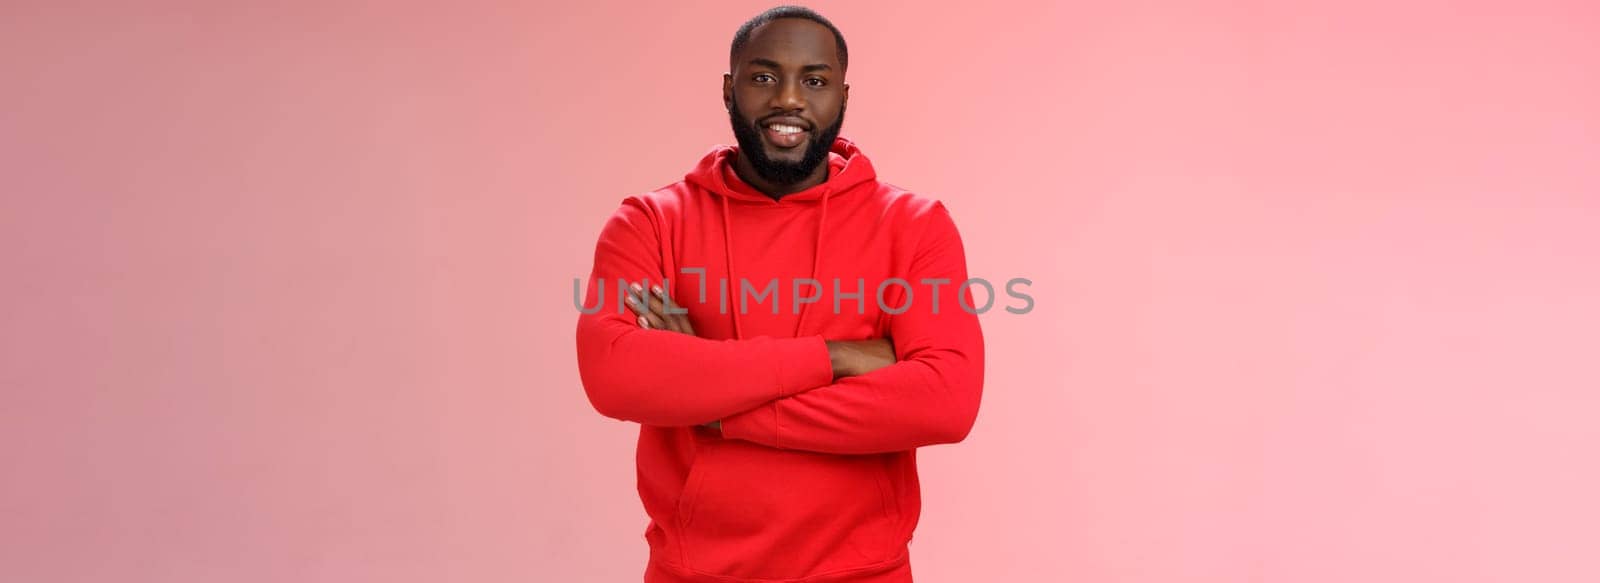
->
[578,138,984,583]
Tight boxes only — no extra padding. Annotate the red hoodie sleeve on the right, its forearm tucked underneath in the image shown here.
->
[722,203,984,453]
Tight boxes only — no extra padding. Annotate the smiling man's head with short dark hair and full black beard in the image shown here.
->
[722,18,850,184]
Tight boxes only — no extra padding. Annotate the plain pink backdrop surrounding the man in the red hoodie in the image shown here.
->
[0,0,1600,583]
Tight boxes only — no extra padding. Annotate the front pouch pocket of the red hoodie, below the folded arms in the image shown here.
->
[678,440,904,578]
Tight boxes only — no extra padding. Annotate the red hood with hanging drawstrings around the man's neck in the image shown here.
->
[683,138,878,338]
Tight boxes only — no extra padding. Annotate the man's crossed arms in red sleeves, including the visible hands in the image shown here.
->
[578,199,984,453]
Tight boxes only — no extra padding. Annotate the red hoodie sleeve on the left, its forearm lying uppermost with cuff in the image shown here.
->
[574,197,834,426]
